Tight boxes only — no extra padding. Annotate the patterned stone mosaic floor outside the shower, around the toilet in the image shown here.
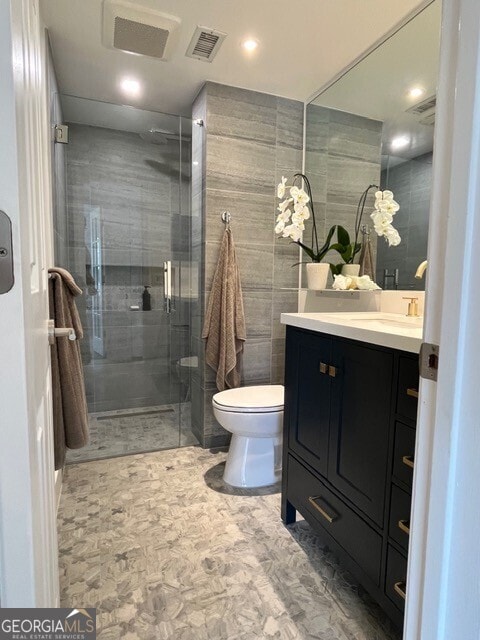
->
[59,447,400,640]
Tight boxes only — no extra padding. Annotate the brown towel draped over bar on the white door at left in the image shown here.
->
[49,267,88,469]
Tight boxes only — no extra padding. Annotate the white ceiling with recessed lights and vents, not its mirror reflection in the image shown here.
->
[41,0,424,116]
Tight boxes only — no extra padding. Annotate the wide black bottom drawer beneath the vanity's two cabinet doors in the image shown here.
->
[287,456,382,585]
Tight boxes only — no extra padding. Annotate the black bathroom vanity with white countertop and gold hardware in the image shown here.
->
[282,313,422,626]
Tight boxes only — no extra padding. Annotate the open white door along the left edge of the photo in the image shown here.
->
[0,0,59,607]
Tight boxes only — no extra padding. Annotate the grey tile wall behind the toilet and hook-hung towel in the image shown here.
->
[192,82,303,446]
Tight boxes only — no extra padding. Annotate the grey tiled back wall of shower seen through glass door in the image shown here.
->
[67,124,189,411]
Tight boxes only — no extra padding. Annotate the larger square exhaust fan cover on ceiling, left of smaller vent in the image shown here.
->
[103,0,180,60]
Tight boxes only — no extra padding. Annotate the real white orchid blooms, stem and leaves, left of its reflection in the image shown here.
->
[275,173,336,266]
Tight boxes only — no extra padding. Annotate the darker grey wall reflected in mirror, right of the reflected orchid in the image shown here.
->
[377,153,432,290]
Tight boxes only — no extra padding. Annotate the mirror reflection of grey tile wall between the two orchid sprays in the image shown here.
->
[302,104,382,286]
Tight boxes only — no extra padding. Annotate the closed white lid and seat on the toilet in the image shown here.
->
[213,384,285,413]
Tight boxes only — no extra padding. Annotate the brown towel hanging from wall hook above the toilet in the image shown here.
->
[202,229,246,391]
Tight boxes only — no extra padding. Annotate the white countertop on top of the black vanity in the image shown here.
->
[281,311,423,353]
